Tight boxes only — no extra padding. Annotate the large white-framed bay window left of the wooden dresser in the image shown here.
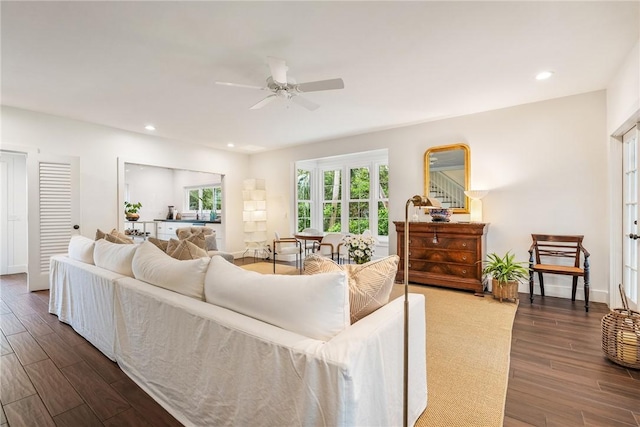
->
[296,150,389,241]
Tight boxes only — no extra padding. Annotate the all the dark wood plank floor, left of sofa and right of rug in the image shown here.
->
[0,275,640,427]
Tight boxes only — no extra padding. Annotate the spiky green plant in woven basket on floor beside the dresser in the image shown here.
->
[482,252,529,302]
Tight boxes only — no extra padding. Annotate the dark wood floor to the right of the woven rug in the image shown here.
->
[504,294,640,427]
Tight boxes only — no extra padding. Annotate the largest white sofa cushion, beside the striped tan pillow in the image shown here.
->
[204,256,350,341]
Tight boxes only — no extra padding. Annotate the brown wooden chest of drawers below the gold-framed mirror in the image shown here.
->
[394,221,488,295]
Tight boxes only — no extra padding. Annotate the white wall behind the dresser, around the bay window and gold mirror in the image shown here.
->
[250,91,609,302]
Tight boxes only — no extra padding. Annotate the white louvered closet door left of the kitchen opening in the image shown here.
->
[27,154,80,291]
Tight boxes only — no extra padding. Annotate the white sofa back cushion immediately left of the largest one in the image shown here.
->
[133,242,210,300]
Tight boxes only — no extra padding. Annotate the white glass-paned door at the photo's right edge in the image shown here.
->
[622,125,640,310]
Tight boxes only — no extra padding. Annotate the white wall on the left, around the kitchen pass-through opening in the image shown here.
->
[0,106,249,252]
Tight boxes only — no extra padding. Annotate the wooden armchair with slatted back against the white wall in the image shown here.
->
[529,234,589,312]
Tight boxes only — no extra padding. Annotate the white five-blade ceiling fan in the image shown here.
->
[216,56,344,111]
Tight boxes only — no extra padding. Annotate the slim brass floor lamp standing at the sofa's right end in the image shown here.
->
[402,195,440,427]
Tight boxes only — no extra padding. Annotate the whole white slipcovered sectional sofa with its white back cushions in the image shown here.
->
[49,238,427,426]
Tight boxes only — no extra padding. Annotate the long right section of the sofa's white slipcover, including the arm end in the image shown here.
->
[116,278,427,426]
